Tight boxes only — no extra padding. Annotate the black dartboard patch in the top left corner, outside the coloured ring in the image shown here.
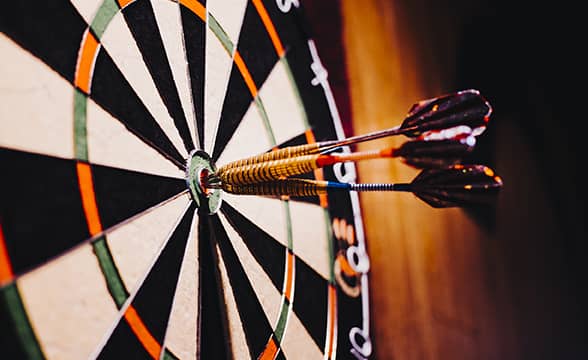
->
[0,1,88,83]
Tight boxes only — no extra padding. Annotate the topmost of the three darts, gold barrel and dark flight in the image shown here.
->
[219,89,492,171]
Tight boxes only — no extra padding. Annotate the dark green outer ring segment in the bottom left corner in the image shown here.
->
[0,283,45,359]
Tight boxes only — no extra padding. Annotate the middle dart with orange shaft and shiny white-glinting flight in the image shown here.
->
[214,125,476,185]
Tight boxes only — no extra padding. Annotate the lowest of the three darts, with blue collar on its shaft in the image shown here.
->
[215,165,502,208]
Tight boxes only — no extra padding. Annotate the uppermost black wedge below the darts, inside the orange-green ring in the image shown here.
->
[221,202,286,292]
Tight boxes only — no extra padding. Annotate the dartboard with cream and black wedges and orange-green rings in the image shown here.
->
[0,0,371,359]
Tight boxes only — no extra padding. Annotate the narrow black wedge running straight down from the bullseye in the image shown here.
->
[196,206,231,359]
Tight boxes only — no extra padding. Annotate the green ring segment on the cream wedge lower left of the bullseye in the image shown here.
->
[92,236,129,309]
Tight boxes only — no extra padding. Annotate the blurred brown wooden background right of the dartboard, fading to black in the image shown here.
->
[303,0,588,359]
